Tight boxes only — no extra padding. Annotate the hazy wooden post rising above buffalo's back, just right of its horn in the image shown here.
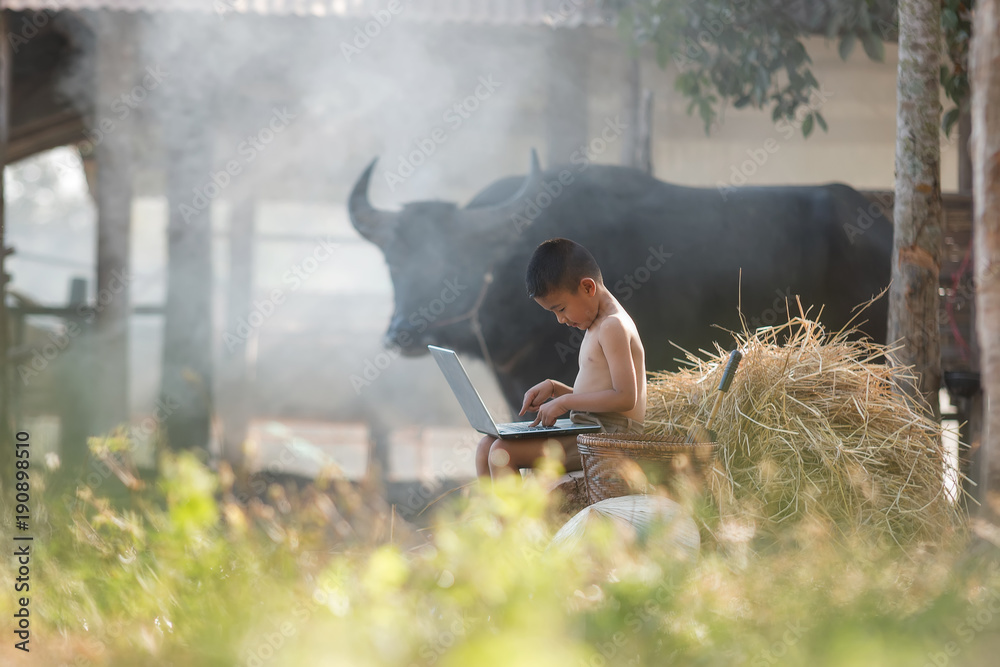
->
[543,28,584,166]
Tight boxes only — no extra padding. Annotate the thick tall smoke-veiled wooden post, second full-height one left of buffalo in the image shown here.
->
[148,12,217,460]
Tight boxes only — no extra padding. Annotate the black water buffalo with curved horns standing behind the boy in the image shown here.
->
[348,154,892,407]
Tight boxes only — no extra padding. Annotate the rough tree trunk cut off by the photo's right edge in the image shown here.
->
[970,0,1000,513]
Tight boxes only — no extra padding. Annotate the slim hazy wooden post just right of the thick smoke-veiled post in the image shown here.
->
[219,200,255,468]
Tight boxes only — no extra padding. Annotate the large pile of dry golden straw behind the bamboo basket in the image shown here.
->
[646,317,961,545]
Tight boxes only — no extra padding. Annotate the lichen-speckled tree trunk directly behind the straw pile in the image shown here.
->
[889,0,941,417]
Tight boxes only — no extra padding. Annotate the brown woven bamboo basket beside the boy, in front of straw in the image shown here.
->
[577,433,717,504]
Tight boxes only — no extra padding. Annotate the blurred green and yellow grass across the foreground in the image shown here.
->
[0,446,1000,667]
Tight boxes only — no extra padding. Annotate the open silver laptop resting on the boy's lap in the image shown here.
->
[427,345,601,440]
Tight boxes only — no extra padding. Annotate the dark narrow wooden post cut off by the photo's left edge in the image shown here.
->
[0,9,14,454]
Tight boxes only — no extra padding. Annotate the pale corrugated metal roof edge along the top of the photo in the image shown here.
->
[2,0,613,27]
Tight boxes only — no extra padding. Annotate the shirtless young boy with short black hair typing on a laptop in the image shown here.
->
[476,238,646,479]
